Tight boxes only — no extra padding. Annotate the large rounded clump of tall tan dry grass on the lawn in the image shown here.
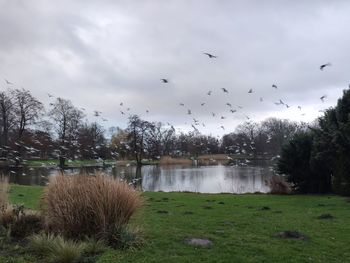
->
[43,174,142,239]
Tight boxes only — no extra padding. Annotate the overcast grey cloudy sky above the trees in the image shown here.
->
[0,0,350,135]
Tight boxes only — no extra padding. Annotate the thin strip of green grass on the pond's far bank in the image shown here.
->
[25,159,115,167]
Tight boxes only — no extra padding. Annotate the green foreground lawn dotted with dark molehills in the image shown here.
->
[4,186,350,263]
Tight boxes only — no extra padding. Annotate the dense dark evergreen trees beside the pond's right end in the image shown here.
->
[278,90,350,195]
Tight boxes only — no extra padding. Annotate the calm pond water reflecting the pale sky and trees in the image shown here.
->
[3,162,273,193]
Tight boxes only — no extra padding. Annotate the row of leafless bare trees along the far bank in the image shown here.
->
[0,89,306,167]
